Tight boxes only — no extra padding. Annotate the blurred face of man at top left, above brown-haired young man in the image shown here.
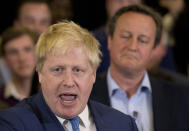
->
[15,3,51,35]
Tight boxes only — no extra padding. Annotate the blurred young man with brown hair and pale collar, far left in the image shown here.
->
[0,27,37,109]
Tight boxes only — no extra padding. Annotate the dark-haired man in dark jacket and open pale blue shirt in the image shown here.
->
[91,5,189,131]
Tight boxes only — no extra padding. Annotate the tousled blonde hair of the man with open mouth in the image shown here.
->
[35,21,102,71]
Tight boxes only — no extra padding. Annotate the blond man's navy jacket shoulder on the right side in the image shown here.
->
[89,101,136,131]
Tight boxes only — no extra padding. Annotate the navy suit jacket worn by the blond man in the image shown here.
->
[0,93,138,131]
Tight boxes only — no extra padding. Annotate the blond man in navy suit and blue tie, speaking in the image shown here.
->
[0,21,138,131]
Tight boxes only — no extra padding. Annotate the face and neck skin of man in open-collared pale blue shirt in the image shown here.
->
[108,12,156,98]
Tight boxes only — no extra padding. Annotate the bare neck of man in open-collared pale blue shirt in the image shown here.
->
[110,67,144,98]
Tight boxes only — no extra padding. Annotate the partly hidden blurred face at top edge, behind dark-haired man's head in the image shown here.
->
[106,0,142,18]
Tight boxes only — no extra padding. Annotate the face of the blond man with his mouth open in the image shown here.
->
[38,48,96,118]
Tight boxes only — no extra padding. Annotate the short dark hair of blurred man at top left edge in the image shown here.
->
[15,0,51,19]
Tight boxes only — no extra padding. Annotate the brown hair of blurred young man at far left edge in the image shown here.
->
[0,27,38,56]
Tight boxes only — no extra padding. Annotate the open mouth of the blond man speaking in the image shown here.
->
[60,94,77,103]
